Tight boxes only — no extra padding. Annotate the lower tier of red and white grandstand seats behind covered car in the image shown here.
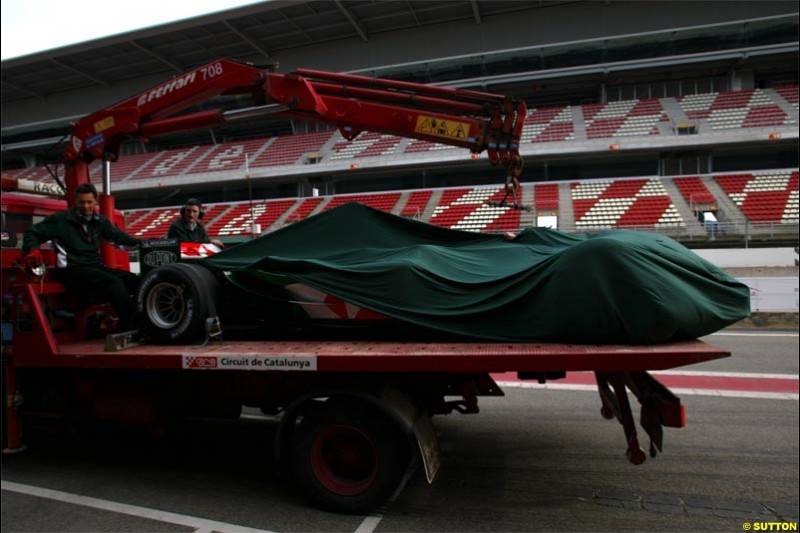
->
[115,169,798,246]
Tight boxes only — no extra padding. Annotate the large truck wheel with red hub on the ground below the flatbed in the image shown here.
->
[292,402,410,514]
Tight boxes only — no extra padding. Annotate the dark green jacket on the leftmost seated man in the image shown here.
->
[22,207,142,268]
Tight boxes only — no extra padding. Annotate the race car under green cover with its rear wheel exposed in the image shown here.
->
[137,204,750,344]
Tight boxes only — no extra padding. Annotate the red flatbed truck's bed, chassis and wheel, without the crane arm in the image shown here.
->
[4,283,730,513]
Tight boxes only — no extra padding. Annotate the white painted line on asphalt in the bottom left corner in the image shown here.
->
[0,480,272,533]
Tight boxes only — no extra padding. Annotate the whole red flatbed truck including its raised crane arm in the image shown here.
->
[3,60,730,513]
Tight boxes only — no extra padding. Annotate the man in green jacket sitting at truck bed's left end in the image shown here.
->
[22,183,141,331]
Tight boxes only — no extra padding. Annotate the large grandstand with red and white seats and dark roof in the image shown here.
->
[2,0,800,246]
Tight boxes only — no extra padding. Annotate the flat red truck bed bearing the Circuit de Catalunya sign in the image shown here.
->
[16,340,730,373]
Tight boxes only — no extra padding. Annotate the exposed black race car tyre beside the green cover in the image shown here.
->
[136,263,219,344]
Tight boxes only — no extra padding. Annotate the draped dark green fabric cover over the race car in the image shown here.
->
[203,203,750,344]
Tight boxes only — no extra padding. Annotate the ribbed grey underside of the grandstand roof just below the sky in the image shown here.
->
[2,0,570,104]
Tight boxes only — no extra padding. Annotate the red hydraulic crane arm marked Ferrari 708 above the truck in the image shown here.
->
[65,60,526,197]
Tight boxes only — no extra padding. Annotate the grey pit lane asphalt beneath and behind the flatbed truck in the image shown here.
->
[2,330,800,533]
